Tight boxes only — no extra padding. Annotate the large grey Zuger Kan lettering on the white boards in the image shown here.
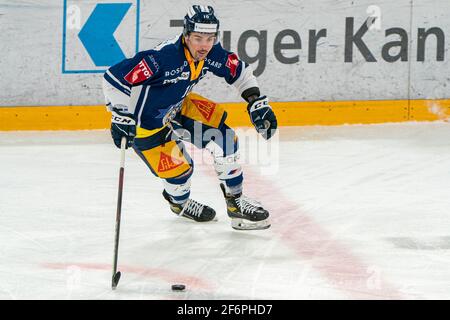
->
[170,17,445,76]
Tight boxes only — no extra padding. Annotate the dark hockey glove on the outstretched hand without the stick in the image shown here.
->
[247,96,277,140]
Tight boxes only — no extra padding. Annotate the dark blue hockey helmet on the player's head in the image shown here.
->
[183,5,219,35]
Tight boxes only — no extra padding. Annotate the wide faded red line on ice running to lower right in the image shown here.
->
[244,167,402,299]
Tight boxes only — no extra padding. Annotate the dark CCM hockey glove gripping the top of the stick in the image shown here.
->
[111,109,136,149]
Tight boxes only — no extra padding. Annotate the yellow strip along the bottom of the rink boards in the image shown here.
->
[0,99,450,131]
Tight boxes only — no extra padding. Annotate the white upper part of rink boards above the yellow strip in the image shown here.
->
[0,0,450,106]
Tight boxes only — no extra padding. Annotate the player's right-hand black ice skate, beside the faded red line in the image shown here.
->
[220,184,270,230]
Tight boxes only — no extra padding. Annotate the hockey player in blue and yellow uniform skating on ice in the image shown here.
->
[103,5,277,230]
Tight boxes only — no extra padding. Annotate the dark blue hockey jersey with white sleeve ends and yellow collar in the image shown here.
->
[104,35,258,130]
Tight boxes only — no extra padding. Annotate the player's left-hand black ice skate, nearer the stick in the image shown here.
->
[163,190,216,222]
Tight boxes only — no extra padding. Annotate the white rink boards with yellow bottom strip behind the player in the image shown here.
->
[0,0,450,130]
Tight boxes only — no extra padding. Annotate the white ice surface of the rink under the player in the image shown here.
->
[0,122,450,299]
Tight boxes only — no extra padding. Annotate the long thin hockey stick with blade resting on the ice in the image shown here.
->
[111,137,127,290]
